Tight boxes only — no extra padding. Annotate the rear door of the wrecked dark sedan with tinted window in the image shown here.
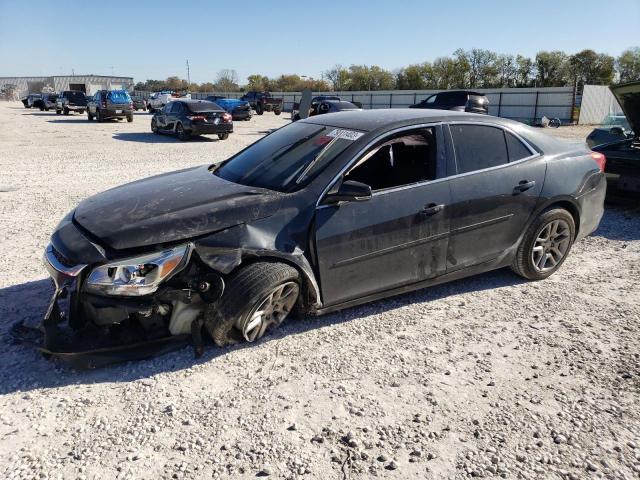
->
[447,123,546,271]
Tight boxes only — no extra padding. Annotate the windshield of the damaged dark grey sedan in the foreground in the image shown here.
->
[215,122,363,192]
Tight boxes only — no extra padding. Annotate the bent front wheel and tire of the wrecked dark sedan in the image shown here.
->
[205,262,301,346]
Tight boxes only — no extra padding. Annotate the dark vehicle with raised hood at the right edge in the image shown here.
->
[593,81,640,193]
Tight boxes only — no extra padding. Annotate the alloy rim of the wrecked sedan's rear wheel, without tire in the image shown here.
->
[531,219,571,273]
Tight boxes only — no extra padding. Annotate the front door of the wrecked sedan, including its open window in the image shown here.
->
[315,127,450,306]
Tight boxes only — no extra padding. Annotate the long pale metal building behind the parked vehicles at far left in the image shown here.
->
[0,75,133,98]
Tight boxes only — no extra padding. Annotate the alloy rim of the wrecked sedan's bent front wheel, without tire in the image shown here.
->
[236,282,300,342]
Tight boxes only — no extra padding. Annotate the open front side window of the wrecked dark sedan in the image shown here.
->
[344,128,437,191]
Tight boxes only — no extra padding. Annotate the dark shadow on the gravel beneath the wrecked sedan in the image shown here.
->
[0,269,524,395]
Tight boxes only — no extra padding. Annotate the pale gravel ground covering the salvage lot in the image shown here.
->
[0,103,640,479]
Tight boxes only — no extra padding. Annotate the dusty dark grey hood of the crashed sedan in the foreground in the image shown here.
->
[74,166,282,250]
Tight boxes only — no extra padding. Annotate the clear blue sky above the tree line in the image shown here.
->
[0,0,640,83]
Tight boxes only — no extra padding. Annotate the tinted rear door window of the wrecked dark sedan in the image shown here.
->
[450,125,509,173]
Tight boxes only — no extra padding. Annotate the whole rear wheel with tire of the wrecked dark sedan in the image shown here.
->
[511,208,576,280]
